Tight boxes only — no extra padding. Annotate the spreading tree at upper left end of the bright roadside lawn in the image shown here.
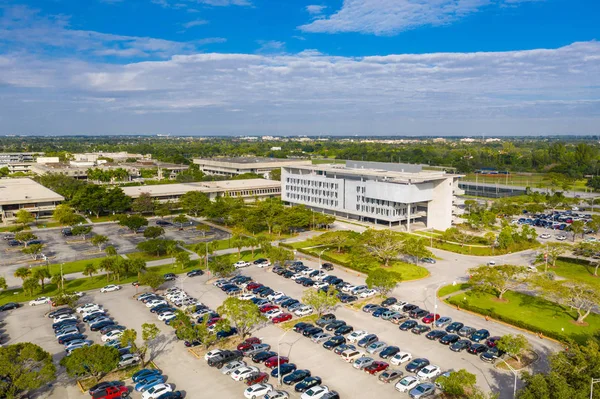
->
[468,265,527,299]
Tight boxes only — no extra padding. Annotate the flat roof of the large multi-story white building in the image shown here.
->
[287,164,462,183]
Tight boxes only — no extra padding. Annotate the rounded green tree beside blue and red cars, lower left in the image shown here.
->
[60,345,120,379]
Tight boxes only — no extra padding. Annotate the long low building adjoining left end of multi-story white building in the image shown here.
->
[123,179,281,202]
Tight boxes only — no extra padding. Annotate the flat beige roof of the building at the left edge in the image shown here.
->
[0,178,65,205]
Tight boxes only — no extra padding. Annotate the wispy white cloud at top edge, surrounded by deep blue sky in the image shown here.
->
[300,0,536,35]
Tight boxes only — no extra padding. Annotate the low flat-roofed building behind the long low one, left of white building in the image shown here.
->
[194,157,311,179]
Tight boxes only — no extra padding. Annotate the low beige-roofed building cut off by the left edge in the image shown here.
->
[0,178,64,224]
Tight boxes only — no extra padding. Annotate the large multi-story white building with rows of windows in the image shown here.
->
[281,161,460,230]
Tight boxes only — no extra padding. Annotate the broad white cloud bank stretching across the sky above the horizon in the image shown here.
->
[0,42,600,134]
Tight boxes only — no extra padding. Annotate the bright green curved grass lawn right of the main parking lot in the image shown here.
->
[446,291,600,343]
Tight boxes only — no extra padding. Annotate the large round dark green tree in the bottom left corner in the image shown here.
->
[0,342,56,399]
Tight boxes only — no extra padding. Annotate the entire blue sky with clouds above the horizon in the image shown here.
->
[0,0,600,136]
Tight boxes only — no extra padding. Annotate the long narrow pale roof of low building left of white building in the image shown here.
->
[122,179,281,198]
